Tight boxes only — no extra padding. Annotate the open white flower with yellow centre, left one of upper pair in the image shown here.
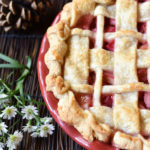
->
[0,106,17,120]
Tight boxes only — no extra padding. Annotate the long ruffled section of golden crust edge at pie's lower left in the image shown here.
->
[58,92,111,142]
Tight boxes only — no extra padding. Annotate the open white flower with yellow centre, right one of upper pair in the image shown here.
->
[21,105,38,120]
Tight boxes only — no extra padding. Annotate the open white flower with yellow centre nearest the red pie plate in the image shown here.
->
[40,124,55,137]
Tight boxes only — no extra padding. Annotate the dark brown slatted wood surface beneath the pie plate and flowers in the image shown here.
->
[0,0,84,150]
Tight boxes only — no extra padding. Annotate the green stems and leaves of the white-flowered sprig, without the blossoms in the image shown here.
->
[0,53,54,149]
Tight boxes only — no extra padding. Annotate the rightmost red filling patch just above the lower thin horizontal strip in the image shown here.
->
[137,68,148,84]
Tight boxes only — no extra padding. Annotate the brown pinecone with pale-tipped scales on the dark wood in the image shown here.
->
[0,0,51,32]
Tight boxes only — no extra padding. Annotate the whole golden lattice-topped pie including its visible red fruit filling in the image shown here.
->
[45,0,150,150]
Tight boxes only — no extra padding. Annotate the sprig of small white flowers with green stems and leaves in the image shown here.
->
[0,53,54,150]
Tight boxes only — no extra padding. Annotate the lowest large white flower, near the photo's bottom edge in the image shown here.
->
[7,131,23,150]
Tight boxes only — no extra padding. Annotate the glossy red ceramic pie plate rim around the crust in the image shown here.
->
[37,13,116,150]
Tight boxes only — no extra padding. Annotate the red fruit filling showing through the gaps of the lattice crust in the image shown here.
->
[75,15,150,109]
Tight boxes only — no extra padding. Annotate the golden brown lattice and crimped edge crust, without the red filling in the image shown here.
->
[45,0,150,150]
